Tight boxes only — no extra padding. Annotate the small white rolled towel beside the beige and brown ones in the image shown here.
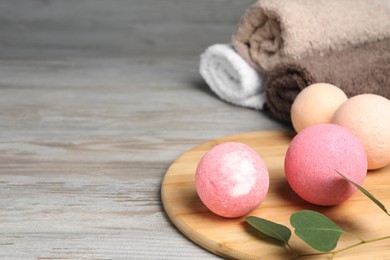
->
[199,44,265,109]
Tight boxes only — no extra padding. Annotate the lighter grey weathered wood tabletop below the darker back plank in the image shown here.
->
[0,55,285,259]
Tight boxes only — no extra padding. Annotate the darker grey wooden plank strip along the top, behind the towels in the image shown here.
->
[0,0,254,57]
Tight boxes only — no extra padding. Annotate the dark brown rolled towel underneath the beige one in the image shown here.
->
[265,38,390,121]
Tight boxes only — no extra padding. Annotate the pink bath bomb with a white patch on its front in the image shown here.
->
[195,142,269,218]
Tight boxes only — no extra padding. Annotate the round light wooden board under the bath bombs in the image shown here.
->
[161,131,390,259]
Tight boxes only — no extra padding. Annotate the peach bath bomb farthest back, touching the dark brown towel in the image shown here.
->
[291,83,348,132]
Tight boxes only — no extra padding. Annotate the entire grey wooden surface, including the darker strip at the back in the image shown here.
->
[0,0,289,259]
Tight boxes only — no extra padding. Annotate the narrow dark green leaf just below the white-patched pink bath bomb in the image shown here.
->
[246,216,291,243]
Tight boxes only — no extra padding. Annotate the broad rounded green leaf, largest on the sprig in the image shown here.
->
[290,210,345,252]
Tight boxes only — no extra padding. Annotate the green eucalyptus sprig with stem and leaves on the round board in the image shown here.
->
[246,171,390,258]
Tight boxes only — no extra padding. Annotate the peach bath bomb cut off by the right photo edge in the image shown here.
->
[332,94,390,170]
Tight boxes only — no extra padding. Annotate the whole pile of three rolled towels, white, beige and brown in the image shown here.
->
[200,0,390,121]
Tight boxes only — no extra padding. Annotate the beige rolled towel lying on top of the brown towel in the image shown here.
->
[233,0,390,72]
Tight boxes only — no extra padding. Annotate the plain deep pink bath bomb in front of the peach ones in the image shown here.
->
[284,124,367,206]
